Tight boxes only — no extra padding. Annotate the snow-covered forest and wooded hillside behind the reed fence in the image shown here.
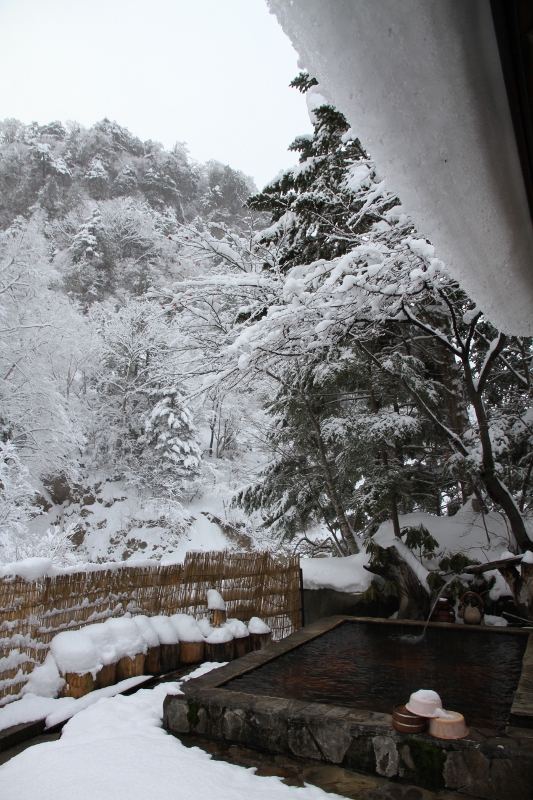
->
[0,78,533,618]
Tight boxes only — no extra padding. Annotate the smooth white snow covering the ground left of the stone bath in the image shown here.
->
[0,665,336,800]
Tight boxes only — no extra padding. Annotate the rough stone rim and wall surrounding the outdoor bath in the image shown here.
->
[163,617,533,800]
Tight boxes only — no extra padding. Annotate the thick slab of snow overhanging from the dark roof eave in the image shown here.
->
[267,0,533,335]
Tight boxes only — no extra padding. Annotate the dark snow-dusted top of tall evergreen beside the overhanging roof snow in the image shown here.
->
[248,73,399,270]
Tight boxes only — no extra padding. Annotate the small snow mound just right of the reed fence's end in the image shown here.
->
[300,552,373,592]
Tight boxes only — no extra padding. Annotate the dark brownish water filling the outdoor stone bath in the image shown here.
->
[225,622,527,728]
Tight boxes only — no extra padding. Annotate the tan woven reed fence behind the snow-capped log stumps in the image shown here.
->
[0,551,301,705]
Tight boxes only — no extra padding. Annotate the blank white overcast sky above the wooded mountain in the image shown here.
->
[0,0,311,186]
